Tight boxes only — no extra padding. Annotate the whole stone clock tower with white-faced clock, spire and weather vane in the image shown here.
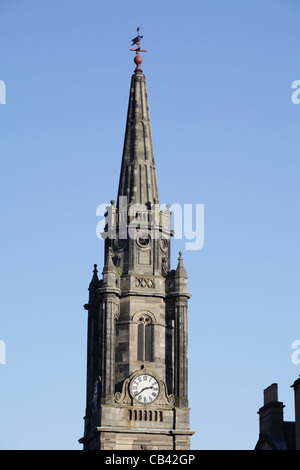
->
[80,30,193,450]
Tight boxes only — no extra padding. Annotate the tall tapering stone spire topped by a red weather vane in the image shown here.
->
[117,36,159,207]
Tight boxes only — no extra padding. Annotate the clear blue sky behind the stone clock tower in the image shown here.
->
[0,0,300,449]
